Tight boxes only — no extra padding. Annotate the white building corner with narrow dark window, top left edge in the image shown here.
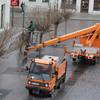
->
[0,0,10,31]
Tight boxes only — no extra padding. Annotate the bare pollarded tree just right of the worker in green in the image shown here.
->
[32,9,52,43]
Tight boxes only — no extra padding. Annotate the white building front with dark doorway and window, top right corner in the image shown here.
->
[76,0,100,15]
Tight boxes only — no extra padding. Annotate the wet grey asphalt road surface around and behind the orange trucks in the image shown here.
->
[0,20,100,100]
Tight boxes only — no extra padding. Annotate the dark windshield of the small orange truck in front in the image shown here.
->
[29,62,52,80]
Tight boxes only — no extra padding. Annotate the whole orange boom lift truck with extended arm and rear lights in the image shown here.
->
[28,23,100,63]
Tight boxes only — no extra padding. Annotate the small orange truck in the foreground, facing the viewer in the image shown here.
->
[26,55,67,95]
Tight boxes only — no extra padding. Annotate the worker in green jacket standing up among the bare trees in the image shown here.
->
[27,21,35,42]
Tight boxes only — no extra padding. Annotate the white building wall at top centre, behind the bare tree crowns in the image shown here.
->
[20,0,62,11]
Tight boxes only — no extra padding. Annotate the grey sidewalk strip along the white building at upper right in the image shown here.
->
[70,12,100,21]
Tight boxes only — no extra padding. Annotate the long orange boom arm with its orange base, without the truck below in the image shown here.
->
[28,23,100,51]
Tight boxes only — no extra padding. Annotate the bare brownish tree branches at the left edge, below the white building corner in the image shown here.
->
[0,29,27,57]
